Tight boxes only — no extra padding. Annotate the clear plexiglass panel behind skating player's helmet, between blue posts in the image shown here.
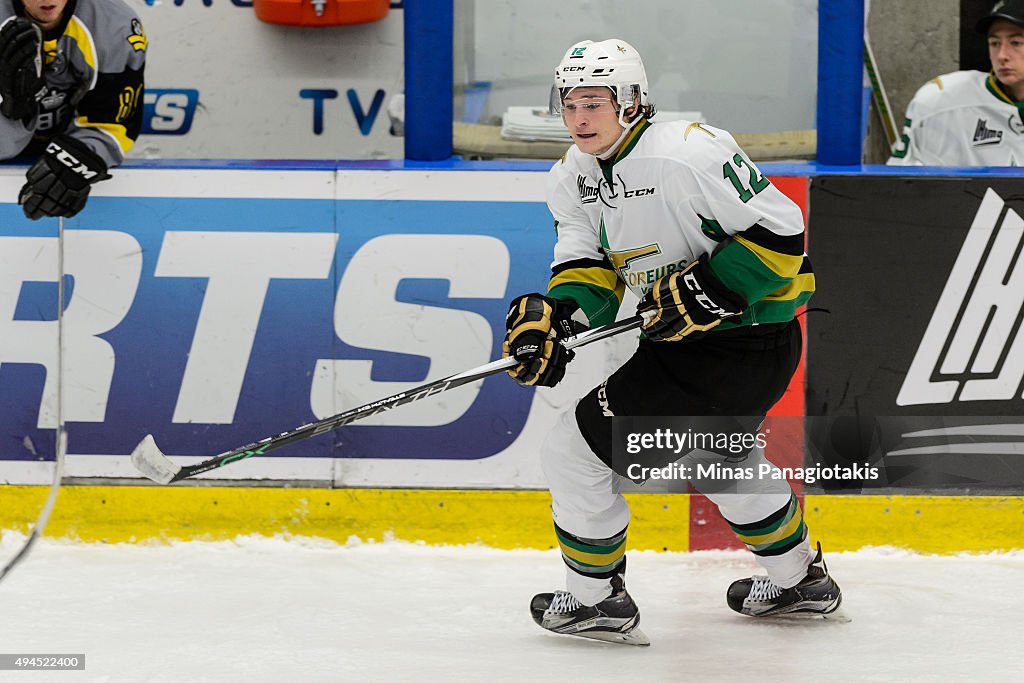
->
[455,0,817,133]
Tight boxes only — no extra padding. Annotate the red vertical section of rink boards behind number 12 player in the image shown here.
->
[690,176,807,550]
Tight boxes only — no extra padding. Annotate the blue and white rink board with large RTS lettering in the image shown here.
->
[0,168,806,488]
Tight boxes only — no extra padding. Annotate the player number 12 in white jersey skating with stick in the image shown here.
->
[505,40,841,644]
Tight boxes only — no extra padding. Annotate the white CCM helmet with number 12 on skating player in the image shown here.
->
[551,38,648,114]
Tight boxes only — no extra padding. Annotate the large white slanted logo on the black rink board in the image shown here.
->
[896,189,1024,405]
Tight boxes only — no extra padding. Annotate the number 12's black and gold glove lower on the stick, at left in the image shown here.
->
[502,294,590,387]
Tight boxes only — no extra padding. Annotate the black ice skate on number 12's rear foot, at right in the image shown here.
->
[725,543,843,616]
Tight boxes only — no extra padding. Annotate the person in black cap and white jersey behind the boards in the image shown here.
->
[889,0,1024,166]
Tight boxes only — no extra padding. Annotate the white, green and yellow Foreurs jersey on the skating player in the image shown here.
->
[547,121,814,327]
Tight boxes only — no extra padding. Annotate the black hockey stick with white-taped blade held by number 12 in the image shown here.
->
[131,313,652,483]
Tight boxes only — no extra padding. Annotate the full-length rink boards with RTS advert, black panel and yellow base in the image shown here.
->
[0,163,1024,552]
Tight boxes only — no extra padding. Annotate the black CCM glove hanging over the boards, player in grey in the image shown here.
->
[17,135,111,220]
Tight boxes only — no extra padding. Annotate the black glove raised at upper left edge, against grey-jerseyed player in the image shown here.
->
[0,16,46,121]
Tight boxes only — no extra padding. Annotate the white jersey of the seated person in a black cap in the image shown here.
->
[888,71,1024,166]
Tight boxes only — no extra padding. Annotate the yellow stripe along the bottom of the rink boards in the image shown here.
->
[0,485,1024,553]
